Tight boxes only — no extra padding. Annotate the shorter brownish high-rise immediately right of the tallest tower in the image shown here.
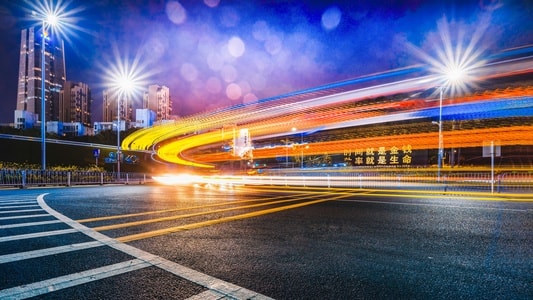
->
[59,81,92,127]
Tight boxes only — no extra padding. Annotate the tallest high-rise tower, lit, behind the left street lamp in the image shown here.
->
[15,27,66,124]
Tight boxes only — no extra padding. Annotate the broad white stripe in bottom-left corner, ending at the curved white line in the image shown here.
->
[0,259,151,299]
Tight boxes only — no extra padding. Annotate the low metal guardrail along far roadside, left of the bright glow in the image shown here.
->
[0,169,152,188]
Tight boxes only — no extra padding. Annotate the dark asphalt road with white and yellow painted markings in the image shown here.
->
[0,185,533,299]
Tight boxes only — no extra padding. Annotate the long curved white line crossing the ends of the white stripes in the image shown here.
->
[37,194,272,300]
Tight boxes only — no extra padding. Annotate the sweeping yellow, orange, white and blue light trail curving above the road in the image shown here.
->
[122,56,533,168]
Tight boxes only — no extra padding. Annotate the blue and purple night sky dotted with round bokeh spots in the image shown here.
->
[0,0,533,123]
